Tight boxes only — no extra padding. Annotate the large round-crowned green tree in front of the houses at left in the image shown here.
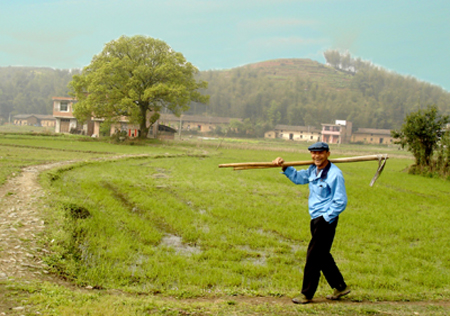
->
[69,36,209,138]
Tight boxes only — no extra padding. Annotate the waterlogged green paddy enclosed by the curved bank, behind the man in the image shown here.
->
[39,143,450,300]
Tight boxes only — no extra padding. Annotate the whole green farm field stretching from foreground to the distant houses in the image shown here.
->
[0,134,450,315]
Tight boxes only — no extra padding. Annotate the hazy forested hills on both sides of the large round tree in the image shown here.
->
[0,56,450,136]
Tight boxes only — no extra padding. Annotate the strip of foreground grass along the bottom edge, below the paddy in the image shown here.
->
[4,282,448,316]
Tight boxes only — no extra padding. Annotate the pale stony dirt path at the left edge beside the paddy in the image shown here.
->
[0,162,70,280]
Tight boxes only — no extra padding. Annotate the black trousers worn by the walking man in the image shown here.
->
[302,216,347,299]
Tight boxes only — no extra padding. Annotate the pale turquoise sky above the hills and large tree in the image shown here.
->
[0,0,450,92]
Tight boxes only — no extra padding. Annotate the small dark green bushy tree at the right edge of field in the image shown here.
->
[391,105,449,167]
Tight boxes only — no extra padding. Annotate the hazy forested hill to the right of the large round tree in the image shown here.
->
[190,56,450,135]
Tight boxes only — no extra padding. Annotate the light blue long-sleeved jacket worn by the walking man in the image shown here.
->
[283,162,347,223]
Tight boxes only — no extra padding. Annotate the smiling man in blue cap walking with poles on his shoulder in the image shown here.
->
[272,142,350,304]
